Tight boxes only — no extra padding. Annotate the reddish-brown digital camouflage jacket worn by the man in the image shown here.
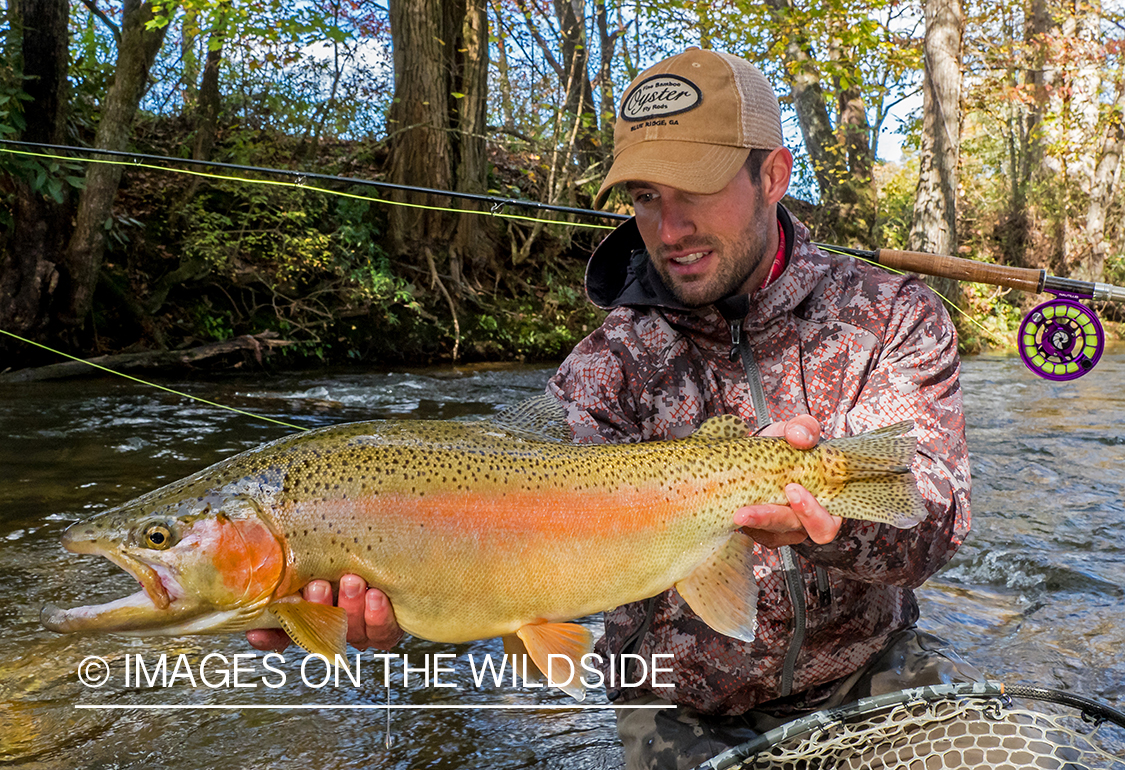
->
[548,207,970,714]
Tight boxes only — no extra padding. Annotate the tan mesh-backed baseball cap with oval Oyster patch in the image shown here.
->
[594,48,784,208]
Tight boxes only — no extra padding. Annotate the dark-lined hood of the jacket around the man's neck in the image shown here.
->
[586,205,808,319]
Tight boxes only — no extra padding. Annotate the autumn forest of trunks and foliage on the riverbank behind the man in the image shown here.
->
[0,0,1125,370]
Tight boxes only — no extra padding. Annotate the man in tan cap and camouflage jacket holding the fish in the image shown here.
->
[250,48,980,769]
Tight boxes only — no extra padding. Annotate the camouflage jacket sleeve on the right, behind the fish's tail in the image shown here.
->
[797,279,970,588]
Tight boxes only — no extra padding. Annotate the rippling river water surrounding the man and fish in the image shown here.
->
[0,348,1125,770]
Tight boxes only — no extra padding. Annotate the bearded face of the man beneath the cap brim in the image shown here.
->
[626,167,777,307]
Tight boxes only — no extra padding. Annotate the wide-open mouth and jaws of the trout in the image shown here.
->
[39,536,172,634]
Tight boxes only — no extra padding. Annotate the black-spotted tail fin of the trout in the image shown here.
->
[821,420,928,529]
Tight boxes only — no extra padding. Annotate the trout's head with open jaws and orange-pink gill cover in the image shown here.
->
[41,490,286,635]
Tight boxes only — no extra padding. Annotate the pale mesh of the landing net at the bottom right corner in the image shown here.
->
[700,682,1125,770]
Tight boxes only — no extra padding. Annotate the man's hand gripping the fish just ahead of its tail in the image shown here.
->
[735,414,842,548]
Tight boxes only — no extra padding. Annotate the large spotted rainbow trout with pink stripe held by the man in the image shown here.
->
[42,396,926,698]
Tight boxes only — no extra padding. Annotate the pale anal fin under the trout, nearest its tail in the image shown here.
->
[676,532,758,642]
